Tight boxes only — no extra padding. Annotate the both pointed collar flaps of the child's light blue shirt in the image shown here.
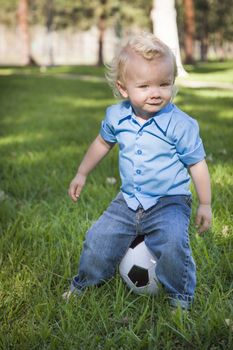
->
[118,101,174,134]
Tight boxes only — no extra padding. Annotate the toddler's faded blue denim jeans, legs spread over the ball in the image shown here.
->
[71,193,196,308]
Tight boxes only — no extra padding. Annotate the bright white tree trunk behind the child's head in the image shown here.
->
[151,0,187,76]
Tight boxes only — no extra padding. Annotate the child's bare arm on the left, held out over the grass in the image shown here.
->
[68,135,114,202]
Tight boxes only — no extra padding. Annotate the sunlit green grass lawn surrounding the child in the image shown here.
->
[0,64,233,350]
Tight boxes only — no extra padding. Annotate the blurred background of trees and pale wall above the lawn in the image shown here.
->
[0,0,233,71]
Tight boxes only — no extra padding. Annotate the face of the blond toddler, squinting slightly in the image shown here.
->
[118,53,174,119]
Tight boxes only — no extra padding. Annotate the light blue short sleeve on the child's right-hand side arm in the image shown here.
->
[173,116,205,166]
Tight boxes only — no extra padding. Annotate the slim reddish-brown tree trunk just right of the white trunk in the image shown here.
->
[183,0,195,64]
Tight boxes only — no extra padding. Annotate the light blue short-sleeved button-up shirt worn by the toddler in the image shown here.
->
[100,101,205,210]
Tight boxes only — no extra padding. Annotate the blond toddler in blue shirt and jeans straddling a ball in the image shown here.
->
[63,33,211,309]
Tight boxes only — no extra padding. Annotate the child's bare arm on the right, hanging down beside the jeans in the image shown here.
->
[189,160,212,233]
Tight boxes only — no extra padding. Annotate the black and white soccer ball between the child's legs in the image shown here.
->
[119,236,159,295]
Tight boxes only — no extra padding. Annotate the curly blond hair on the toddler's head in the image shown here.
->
[105,33,177,97]
